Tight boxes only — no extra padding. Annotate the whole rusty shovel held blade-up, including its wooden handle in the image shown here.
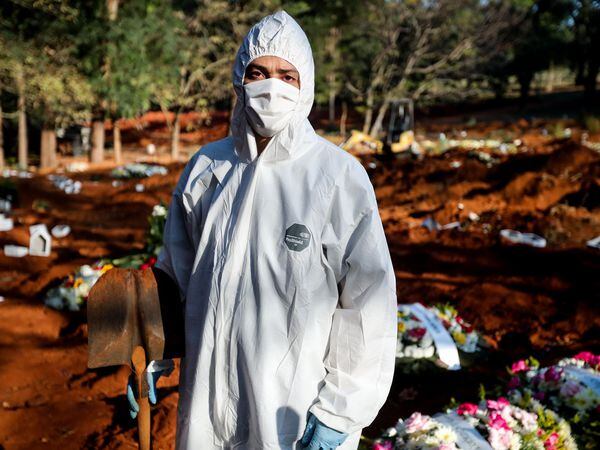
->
[87,269,183,450]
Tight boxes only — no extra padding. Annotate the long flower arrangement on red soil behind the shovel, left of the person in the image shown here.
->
[44,205,167,311]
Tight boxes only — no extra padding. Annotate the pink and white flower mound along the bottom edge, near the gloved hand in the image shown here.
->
[372,397,577,450]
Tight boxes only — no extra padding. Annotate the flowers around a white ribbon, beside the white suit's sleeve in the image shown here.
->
[396,304,484,369]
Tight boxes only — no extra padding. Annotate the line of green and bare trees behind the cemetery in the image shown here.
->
[0,0,600,167]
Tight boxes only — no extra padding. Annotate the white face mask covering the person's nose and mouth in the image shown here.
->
[244,78,300,137]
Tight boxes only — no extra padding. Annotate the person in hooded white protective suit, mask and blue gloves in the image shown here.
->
[127,7,396,450]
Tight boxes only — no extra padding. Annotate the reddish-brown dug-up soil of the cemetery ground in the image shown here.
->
[0,115,600,450]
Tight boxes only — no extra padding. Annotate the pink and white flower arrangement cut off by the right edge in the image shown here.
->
[508,352,600,449]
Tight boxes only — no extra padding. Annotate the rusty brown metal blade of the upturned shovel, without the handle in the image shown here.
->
[87,268,165,368]
